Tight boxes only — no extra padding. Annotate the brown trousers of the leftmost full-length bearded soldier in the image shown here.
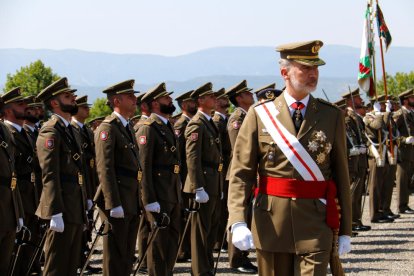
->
[43,222,83,276]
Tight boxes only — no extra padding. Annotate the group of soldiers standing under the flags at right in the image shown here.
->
[336,89,414,234]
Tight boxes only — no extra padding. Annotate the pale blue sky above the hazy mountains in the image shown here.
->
[0,0,414,56]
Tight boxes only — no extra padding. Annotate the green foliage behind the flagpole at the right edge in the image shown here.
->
[377,71,414,95]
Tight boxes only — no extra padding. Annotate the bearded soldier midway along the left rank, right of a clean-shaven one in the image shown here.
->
[136,83,181,275]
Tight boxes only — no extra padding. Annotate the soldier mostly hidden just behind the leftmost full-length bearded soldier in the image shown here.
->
[71,96,102,273]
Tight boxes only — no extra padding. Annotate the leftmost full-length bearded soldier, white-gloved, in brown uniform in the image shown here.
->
[36,78,87,275]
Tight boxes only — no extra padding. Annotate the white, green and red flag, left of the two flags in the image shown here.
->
[358,4,374,97]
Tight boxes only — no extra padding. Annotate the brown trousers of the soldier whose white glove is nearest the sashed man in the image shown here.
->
[191,196,220,276]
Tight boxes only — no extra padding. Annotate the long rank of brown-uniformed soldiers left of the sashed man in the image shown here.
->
[0,78,281,275]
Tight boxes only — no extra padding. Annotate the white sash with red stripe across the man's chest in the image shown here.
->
[255,102,325,181]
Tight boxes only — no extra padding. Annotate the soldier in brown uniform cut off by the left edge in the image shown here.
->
[0,94,24,275]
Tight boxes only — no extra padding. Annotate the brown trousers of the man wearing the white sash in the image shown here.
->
[256,249,330,276]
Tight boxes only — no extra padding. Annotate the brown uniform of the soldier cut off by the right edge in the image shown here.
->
[394,107,414,212]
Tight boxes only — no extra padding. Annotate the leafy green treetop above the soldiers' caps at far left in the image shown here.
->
[4,60,60,96]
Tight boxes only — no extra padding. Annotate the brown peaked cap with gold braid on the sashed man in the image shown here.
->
[276,40,325,66]
